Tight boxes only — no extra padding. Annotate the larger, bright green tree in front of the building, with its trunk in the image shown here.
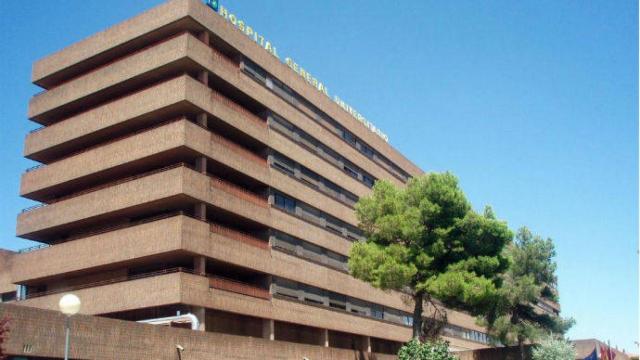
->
[349,172,513,338]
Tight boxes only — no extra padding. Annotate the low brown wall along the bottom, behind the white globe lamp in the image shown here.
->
[0,304,396,360]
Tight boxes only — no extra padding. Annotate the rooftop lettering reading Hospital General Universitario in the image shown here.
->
[205,0,389,142]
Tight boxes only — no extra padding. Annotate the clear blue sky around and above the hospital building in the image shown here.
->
[0,0,638,352]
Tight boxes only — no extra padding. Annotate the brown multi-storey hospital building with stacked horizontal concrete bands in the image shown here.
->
[0,0,560,359]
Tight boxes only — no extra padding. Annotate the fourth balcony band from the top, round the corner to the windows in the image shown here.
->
[21,118,269,203]
